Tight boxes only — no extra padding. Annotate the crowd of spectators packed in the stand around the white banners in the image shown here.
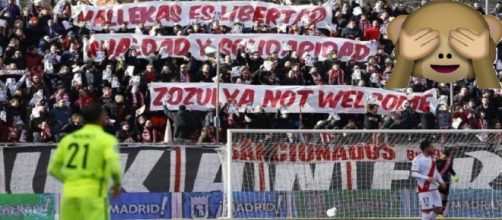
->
[0,0,502,143]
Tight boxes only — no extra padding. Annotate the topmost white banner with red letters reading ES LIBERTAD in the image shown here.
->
[72,1,332,30]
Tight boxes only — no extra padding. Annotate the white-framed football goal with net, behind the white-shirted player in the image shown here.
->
[220,130,502,219]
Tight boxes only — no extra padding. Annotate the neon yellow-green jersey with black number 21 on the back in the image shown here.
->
[48,124,122,198]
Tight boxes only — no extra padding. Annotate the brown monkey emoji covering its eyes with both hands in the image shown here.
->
[385,1,502,89]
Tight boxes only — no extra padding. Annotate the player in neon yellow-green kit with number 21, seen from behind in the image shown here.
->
[48,104,122,220]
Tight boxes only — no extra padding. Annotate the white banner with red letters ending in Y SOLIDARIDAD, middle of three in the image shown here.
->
[84,34,377,61]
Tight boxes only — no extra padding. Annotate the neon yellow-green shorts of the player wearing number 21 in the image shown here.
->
[60,197,110,220]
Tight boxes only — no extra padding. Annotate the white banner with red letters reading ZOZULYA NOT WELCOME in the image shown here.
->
[150,83,438,114]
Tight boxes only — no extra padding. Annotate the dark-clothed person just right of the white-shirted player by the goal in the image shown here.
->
[436,148,459,218]
